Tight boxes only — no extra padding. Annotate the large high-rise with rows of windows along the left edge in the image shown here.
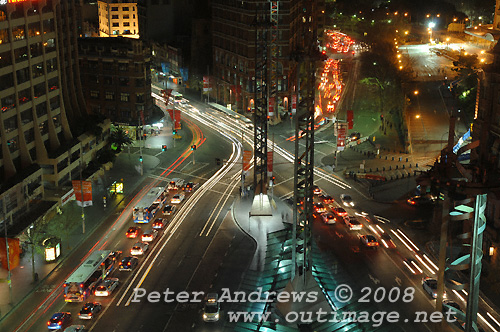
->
[0,0,109,236]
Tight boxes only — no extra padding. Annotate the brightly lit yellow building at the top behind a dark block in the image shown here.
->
[97,0,139,38]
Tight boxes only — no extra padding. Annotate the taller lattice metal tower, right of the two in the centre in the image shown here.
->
[292,0,321,282]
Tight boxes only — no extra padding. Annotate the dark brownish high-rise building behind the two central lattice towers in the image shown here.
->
[211,0,324,114]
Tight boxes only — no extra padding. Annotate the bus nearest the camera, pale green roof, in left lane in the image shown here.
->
[63,250,116,302]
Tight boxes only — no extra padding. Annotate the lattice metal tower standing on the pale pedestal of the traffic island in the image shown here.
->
[253,3,270,195]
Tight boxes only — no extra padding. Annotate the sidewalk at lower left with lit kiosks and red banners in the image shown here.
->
[0,152,159,321]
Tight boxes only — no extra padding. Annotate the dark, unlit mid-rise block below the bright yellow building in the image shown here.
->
[79,38,153,126]
